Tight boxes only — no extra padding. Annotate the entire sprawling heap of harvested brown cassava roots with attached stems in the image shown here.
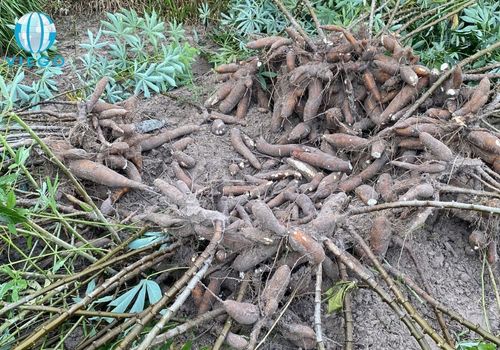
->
[29,10,500,349]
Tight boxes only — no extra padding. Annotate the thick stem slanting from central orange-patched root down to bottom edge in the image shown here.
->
[324,239,430,350]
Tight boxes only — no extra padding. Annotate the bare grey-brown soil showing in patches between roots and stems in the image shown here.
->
[27,13,500,350]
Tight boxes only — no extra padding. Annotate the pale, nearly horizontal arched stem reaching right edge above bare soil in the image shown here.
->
[345,200,500,216]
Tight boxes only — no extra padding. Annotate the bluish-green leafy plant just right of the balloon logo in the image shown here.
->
[77,9,198,102]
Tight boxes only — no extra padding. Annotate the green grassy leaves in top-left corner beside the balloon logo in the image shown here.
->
[0,0,43,55]
